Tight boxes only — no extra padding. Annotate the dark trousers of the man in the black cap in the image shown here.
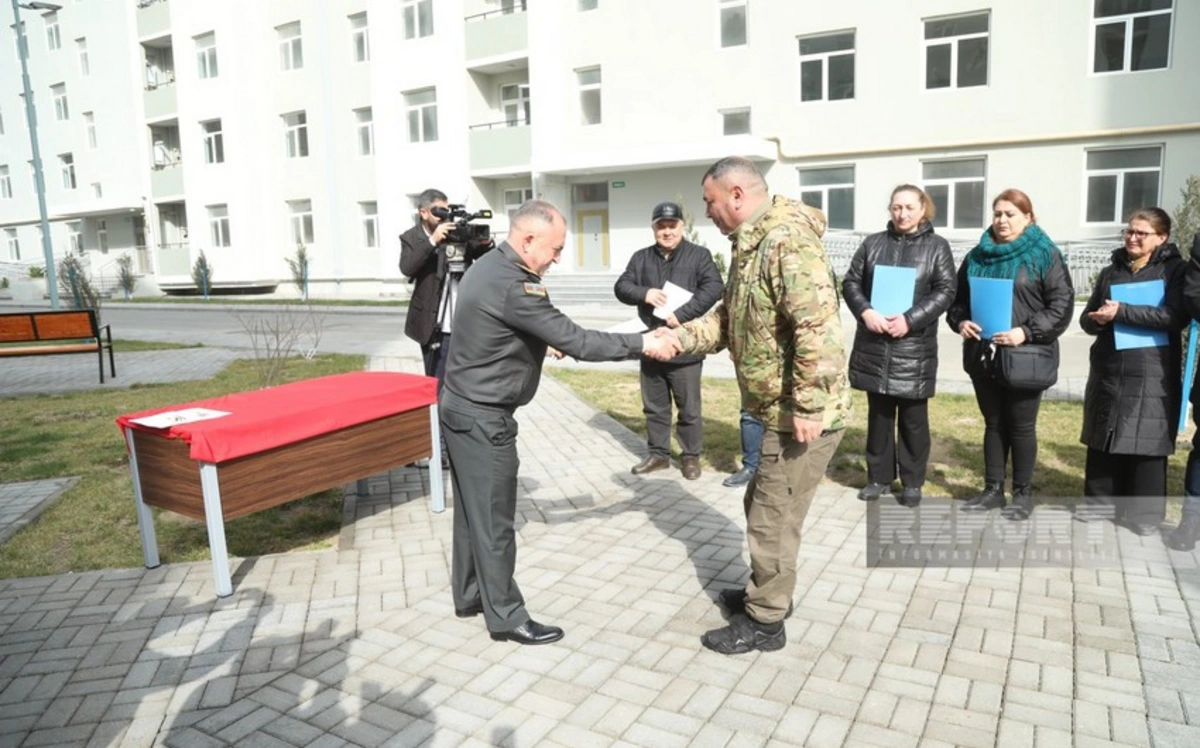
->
[641,359,704,457]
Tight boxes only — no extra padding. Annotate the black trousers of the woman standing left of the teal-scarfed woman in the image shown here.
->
[866,393,930,489]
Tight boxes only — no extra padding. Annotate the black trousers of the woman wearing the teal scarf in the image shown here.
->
[971,377,1042,489]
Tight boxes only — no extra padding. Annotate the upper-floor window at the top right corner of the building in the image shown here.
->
[1092,0,1174,73]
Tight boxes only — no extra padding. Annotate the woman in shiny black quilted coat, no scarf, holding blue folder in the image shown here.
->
[841,185,954,507]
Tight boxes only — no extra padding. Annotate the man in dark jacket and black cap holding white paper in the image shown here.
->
[613,203,725,480]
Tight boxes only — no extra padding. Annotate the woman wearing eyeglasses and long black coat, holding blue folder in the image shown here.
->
[1075,208,1188,535]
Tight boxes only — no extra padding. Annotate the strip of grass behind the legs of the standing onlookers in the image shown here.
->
[547,369,1188,522]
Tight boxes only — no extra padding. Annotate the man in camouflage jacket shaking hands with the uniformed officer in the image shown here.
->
[678,156,850,654]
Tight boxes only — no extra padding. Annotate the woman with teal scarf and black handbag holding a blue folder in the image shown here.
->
[946,190,1075,520]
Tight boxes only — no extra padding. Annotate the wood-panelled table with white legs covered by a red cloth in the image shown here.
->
[116,371,445,597]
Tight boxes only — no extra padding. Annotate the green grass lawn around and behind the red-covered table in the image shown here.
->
[0,352,364,578]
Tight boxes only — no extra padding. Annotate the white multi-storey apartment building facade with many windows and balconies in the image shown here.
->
[0,0,1200,297]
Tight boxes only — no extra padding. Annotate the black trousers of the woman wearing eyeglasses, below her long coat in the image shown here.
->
[1084,447,1166,525]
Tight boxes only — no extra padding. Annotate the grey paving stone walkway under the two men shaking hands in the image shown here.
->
[0,359,1200,748]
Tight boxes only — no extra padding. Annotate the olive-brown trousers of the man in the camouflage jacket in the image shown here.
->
[744,429,842,623]
